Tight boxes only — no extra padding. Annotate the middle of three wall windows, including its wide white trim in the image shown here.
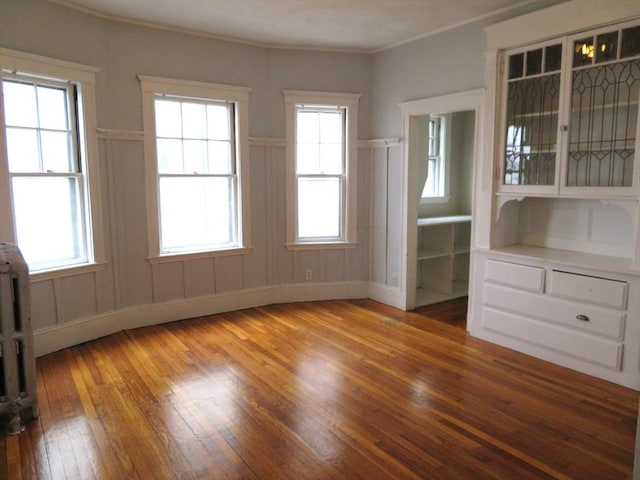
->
[141,77,248,257]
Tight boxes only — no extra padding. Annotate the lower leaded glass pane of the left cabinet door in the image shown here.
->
[503,73,560,185]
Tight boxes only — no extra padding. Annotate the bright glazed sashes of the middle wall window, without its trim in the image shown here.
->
[154,94,240,254]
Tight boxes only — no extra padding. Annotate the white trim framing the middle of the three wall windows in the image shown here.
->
[138,75,251,263]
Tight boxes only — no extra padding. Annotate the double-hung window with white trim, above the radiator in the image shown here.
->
[0,50,102,273]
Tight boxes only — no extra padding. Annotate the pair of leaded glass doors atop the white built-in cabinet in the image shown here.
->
[502,24,640,194]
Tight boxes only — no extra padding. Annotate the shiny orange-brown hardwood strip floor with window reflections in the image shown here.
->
[0,300,639,480]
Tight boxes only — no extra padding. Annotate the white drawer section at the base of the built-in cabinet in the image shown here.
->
[467,248,640,390]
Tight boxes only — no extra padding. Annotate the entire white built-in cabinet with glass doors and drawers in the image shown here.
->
[467,0,640,390]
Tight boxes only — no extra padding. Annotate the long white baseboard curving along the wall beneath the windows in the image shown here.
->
[34,282,370,357]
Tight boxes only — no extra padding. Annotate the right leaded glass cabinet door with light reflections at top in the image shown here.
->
[562,23,640,196]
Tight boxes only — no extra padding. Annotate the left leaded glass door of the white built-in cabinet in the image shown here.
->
[501,41,563,193]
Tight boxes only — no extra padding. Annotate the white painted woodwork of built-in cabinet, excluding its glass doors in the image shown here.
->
[467,0,640,390]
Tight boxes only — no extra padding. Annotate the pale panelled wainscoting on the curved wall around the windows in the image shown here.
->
[32,130,401,353]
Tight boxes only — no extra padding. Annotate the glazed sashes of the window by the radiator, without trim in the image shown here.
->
[2,72,92,273]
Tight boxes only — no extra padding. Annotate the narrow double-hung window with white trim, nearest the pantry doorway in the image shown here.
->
[285,91,358,247]
